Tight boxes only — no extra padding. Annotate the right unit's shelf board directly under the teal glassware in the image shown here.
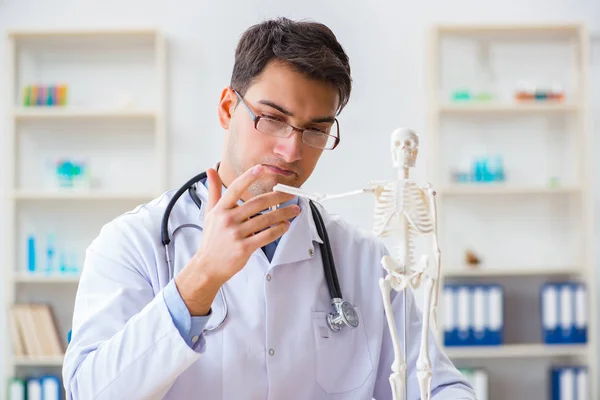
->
[436,183,582,195]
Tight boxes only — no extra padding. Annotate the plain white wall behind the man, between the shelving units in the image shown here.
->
[0,0,600,392]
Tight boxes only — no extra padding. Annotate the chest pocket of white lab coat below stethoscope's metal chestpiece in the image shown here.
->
[312,307,373,394]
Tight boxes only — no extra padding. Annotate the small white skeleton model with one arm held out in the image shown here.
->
[273,128,441,400]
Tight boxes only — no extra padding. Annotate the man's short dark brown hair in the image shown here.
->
[231,18,352,112]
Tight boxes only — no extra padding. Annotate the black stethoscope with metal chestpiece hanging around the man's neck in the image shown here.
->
[160,172,359,333]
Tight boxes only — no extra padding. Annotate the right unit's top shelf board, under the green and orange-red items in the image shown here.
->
[438,101,579,114]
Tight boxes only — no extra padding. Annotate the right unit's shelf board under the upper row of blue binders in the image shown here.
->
[444,344,589,360]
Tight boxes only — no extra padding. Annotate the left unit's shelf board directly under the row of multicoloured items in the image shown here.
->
[13,106,158,120]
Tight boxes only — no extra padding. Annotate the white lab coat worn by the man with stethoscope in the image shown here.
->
[63,185,475,400]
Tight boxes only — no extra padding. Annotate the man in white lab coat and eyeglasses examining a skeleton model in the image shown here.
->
[63,19,475,400]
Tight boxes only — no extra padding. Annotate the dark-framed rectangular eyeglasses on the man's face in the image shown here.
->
[234,90,340,150]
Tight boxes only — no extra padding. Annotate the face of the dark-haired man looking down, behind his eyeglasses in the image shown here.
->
[219,62,339,196]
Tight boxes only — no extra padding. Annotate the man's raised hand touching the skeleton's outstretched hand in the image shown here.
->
[175,165,300,316]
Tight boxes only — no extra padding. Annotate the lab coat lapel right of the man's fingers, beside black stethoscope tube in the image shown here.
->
[271,198,323,267]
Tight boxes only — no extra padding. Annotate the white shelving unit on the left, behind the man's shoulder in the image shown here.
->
[2,29,167,390]
